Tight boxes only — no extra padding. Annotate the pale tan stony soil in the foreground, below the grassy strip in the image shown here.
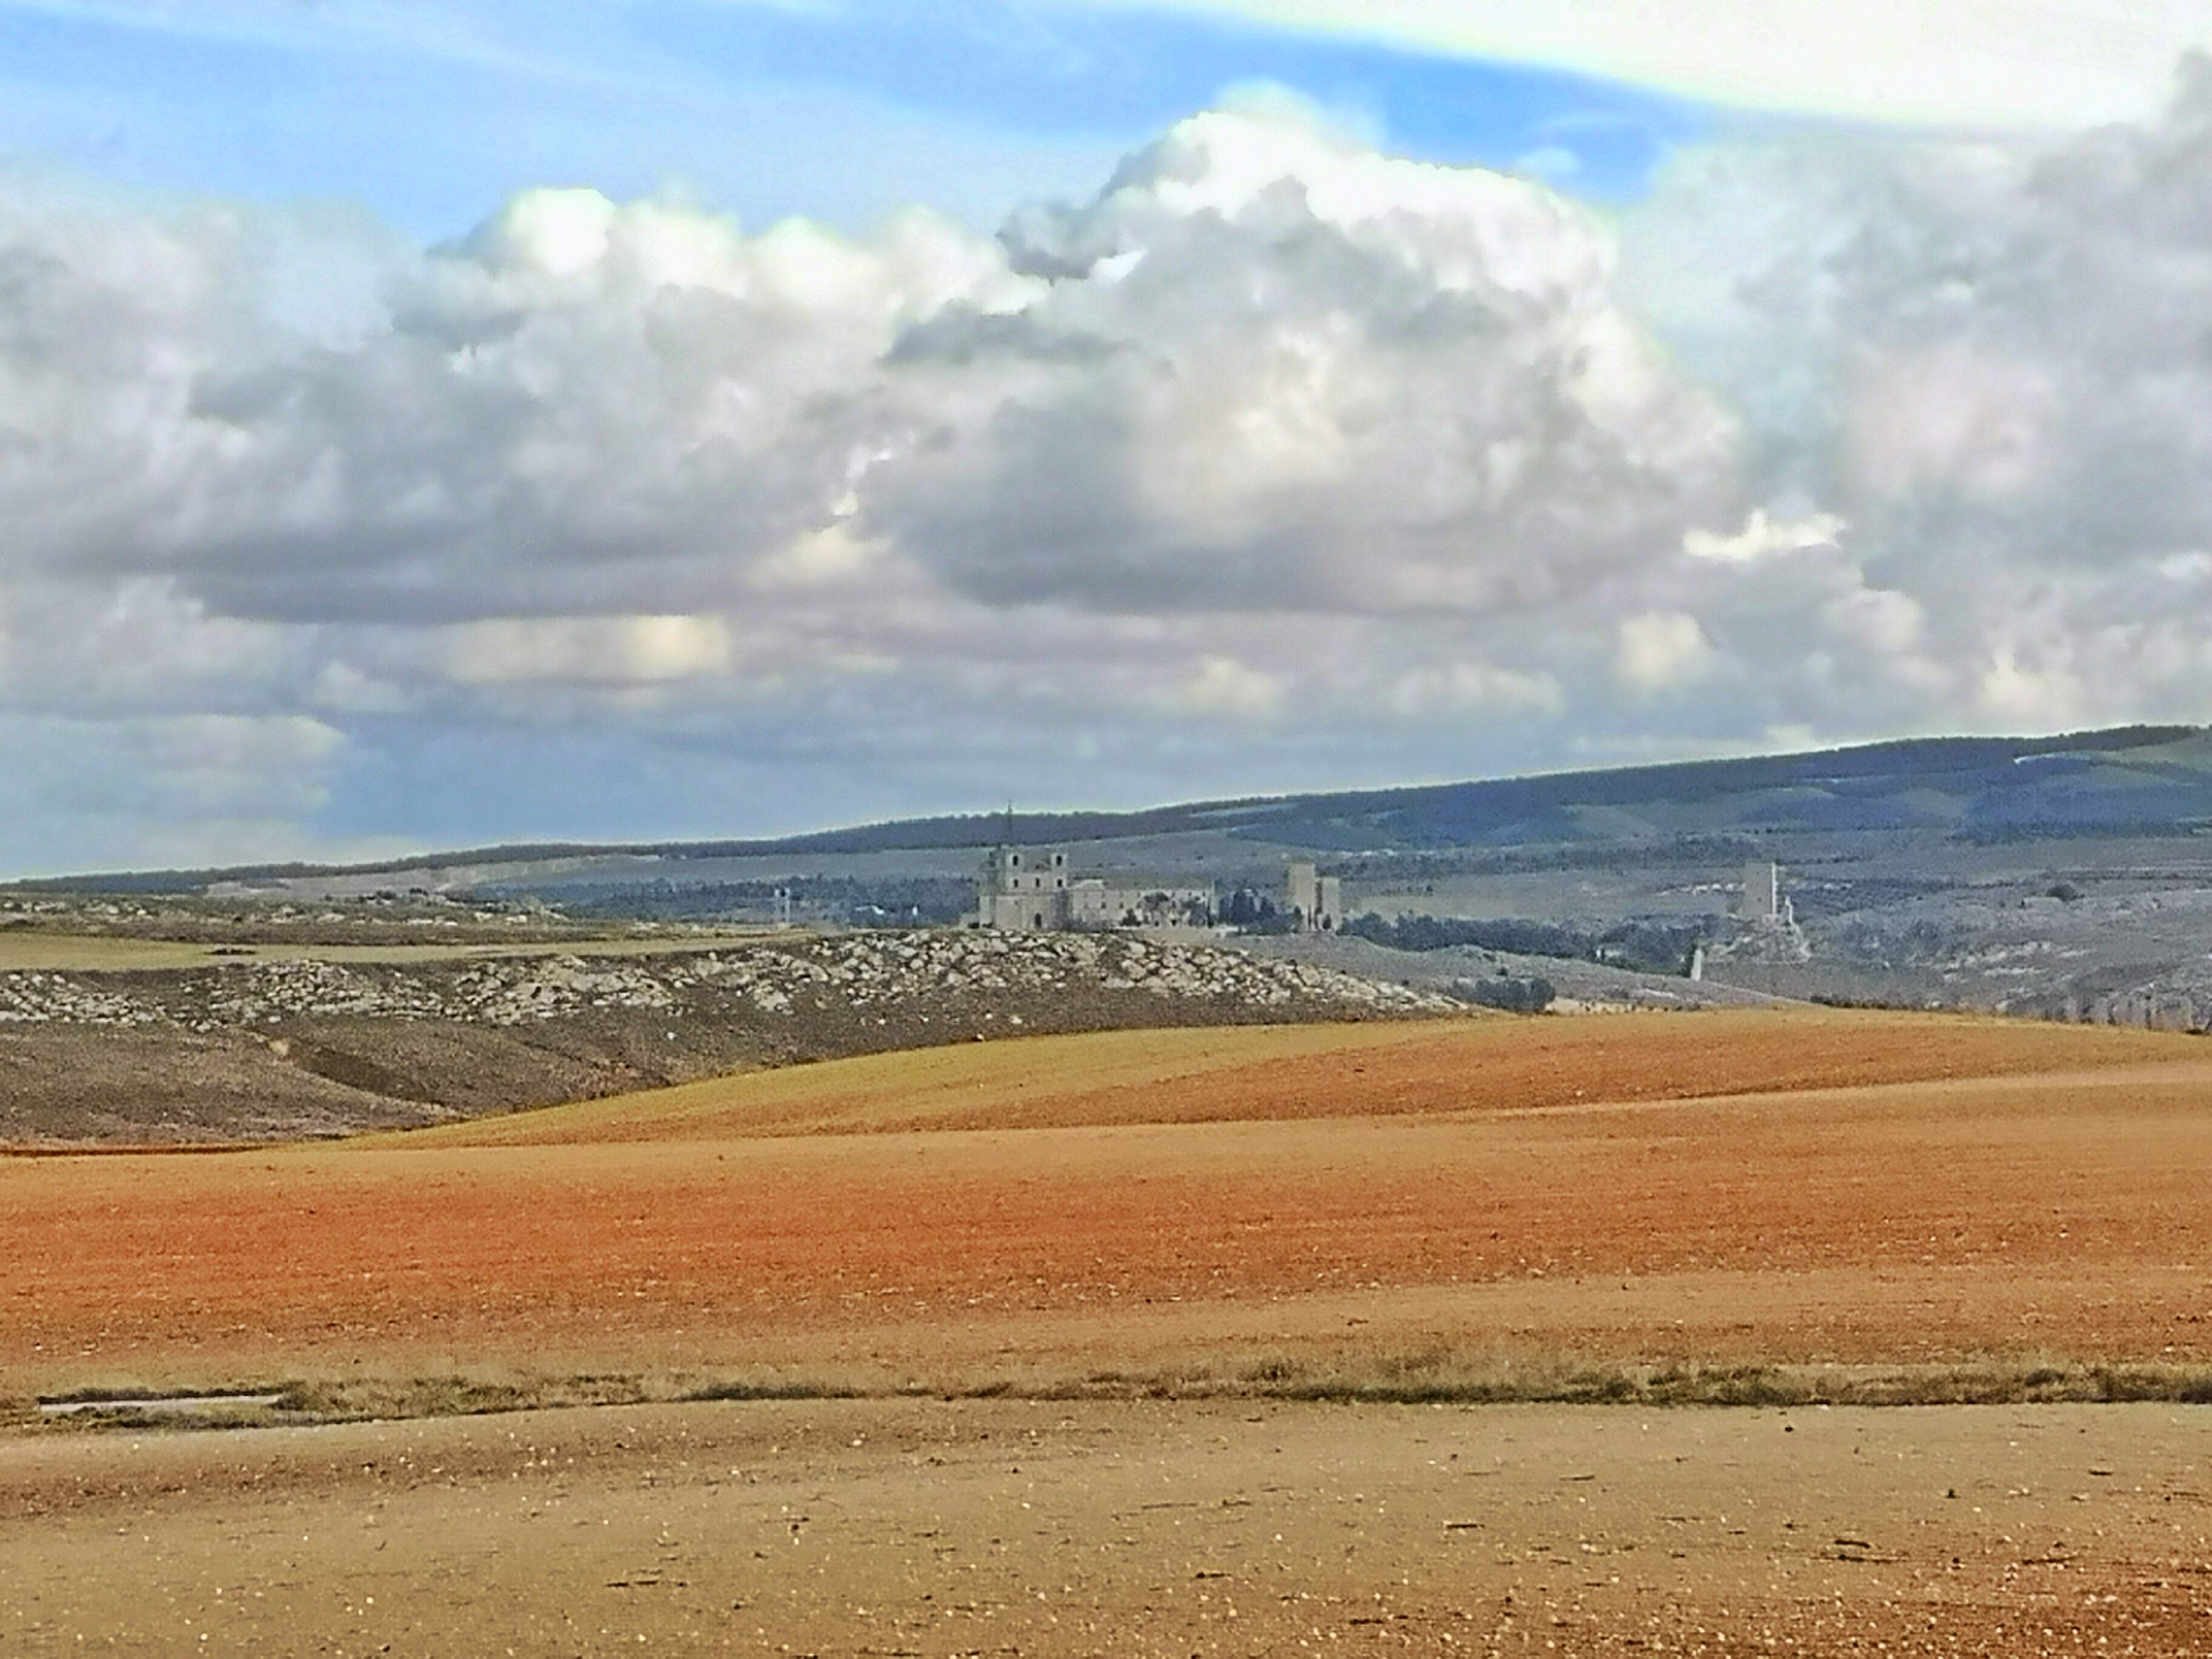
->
[0,1400,2212,1659]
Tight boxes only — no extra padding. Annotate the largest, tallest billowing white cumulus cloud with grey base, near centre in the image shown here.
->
[863,113,1732,615]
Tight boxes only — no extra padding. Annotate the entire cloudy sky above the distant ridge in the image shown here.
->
[0,0,2212,874]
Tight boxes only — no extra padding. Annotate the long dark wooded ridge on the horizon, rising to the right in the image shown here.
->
[16,726,2212,891]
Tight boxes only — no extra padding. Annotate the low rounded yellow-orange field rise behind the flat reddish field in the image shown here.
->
[384,1008,2212,1146]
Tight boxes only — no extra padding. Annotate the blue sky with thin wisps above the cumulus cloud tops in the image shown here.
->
[0,0,1706,239]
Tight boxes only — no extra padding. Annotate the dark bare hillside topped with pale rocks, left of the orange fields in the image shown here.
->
[0,931,1458,1144]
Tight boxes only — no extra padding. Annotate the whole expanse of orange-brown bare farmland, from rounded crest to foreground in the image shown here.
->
[0,1011,2212,1657]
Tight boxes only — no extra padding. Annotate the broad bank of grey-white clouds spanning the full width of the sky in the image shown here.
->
[0,62,2212,860]
